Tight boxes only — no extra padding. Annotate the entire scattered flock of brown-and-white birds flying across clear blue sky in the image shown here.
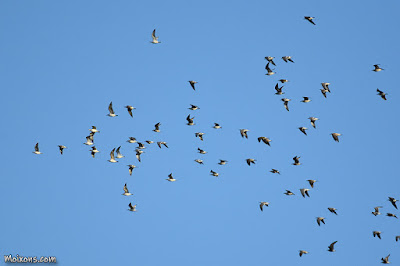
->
[33,16,400,264]
